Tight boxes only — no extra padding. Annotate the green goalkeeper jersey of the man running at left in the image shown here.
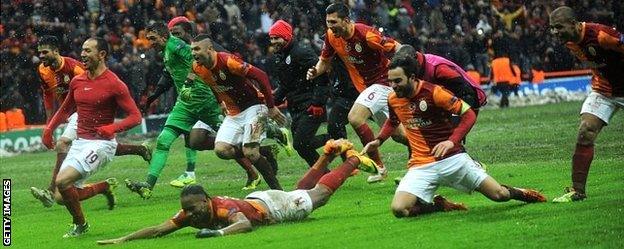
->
[163,36,217,110]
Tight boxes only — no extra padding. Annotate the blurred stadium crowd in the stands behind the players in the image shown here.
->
[0,0,624,124]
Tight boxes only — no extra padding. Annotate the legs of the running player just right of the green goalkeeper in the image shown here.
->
[214,142,281,189]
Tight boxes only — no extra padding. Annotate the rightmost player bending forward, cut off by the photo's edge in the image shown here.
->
[550,6,624,202]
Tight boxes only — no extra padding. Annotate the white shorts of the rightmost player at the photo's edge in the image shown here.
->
[581,92,624,124]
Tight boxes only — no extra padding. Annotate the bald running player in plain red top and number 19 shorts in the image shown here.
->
[42,37,141,238]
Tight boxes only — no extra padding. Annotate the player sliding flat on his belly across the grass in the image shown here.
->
[97,139,377,245]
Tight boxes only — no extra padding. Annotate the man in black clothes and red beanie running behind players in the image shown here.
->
[269,20,329,167]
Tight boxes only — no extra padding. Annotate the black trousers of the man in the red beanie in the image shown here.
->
[290,111,329,167]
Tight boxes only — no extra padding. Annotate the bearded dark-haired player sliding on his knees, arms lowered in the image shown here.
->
[362,56,546,218]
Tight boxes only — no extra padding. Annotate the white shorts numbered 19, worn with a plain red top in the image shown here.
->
[60,139,117,187]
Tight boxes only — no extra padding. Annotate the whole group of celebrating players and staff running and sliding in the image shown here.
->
[26,3,624,244]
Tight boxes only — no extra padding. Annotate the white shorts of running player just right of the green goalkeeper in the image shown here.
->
[215,104,268,145]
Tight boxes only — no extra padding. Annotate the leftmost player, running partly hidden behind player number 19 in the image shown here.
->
[30,36,152,207]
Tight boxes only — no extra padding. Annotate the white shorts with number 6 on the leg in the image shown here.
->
[355,84,392,124]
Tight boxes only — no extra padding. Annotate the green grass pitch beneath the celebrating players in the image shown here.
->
[0,102,624,248]
